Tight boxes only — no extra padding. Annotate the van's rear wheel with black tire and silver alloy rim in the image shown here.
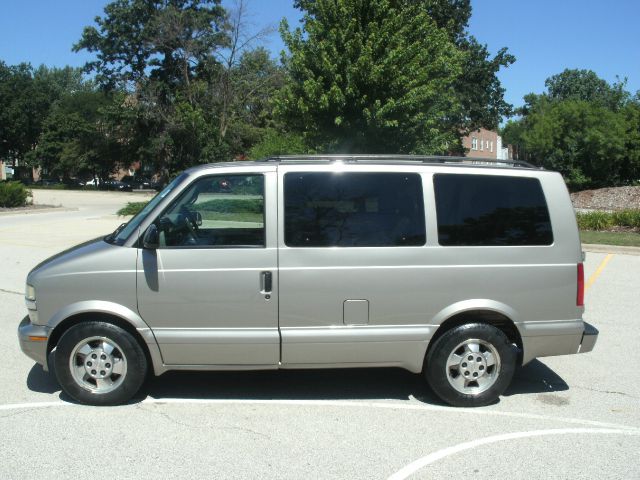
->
[423,323,517,407]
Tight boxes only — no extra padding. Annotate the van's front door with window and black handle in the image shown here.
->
[137,167,280,368]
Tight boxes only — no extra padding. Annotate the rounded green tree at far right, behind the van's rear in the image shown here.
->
[502,70,640,189]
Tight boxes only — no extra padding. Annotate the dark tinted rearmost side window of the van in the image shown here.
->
[433,174,553,246]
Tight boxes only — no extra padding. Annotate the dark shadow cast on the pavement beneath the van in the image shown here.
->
[27,360,569,405]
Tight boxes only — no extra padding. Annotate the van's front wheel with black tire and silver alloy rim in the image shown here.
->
[55,322,148,405]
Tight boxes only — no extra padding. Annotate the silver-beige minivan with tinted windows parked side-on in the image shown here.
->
[18,156,598,406]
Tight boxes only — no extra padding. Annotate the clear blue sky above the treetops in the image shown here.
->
[0,0,640,106]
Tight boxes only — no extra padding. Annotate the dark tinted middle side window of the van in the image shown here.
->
[284,172,426,247]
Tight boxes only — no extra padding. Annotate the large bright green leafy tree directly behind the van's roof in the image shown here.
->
[277,0,513,153]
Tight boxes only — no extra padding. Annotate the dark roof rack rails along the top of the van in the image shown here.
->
[265,154,539,168]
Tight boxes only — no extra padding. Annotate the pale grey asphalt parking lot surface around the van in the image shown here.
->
[0,191,640,479]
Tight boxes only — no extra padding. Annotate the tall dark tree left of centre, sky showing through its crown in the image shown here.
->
[74,0,227,175]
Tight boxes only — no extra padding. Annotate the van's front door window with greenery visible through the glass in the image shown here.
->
[156,175,265,248]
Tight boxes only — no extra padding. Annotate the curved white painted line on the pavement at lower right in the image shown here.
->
[388,428,640,480]
